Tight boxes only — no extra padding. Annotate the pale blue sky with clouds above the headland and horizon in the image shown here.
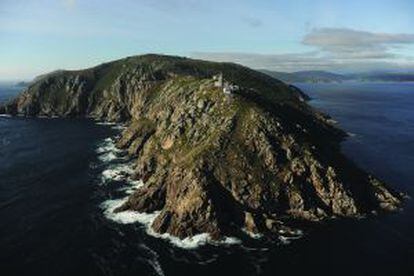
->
[0,0,414,80]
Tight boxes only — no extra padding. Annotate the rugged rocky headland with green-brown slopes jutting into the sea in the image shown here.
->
[0,55,400,238]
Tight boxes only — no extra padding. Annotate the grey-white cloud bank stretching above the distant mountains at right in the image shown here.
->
[192,28,414,72]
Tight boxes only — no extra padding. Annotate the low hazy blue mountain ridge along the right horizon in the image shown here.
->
[260,69,414,83]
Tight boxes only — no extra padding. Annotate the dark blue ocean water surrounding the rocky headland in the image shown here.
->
[0,83,414,275]
